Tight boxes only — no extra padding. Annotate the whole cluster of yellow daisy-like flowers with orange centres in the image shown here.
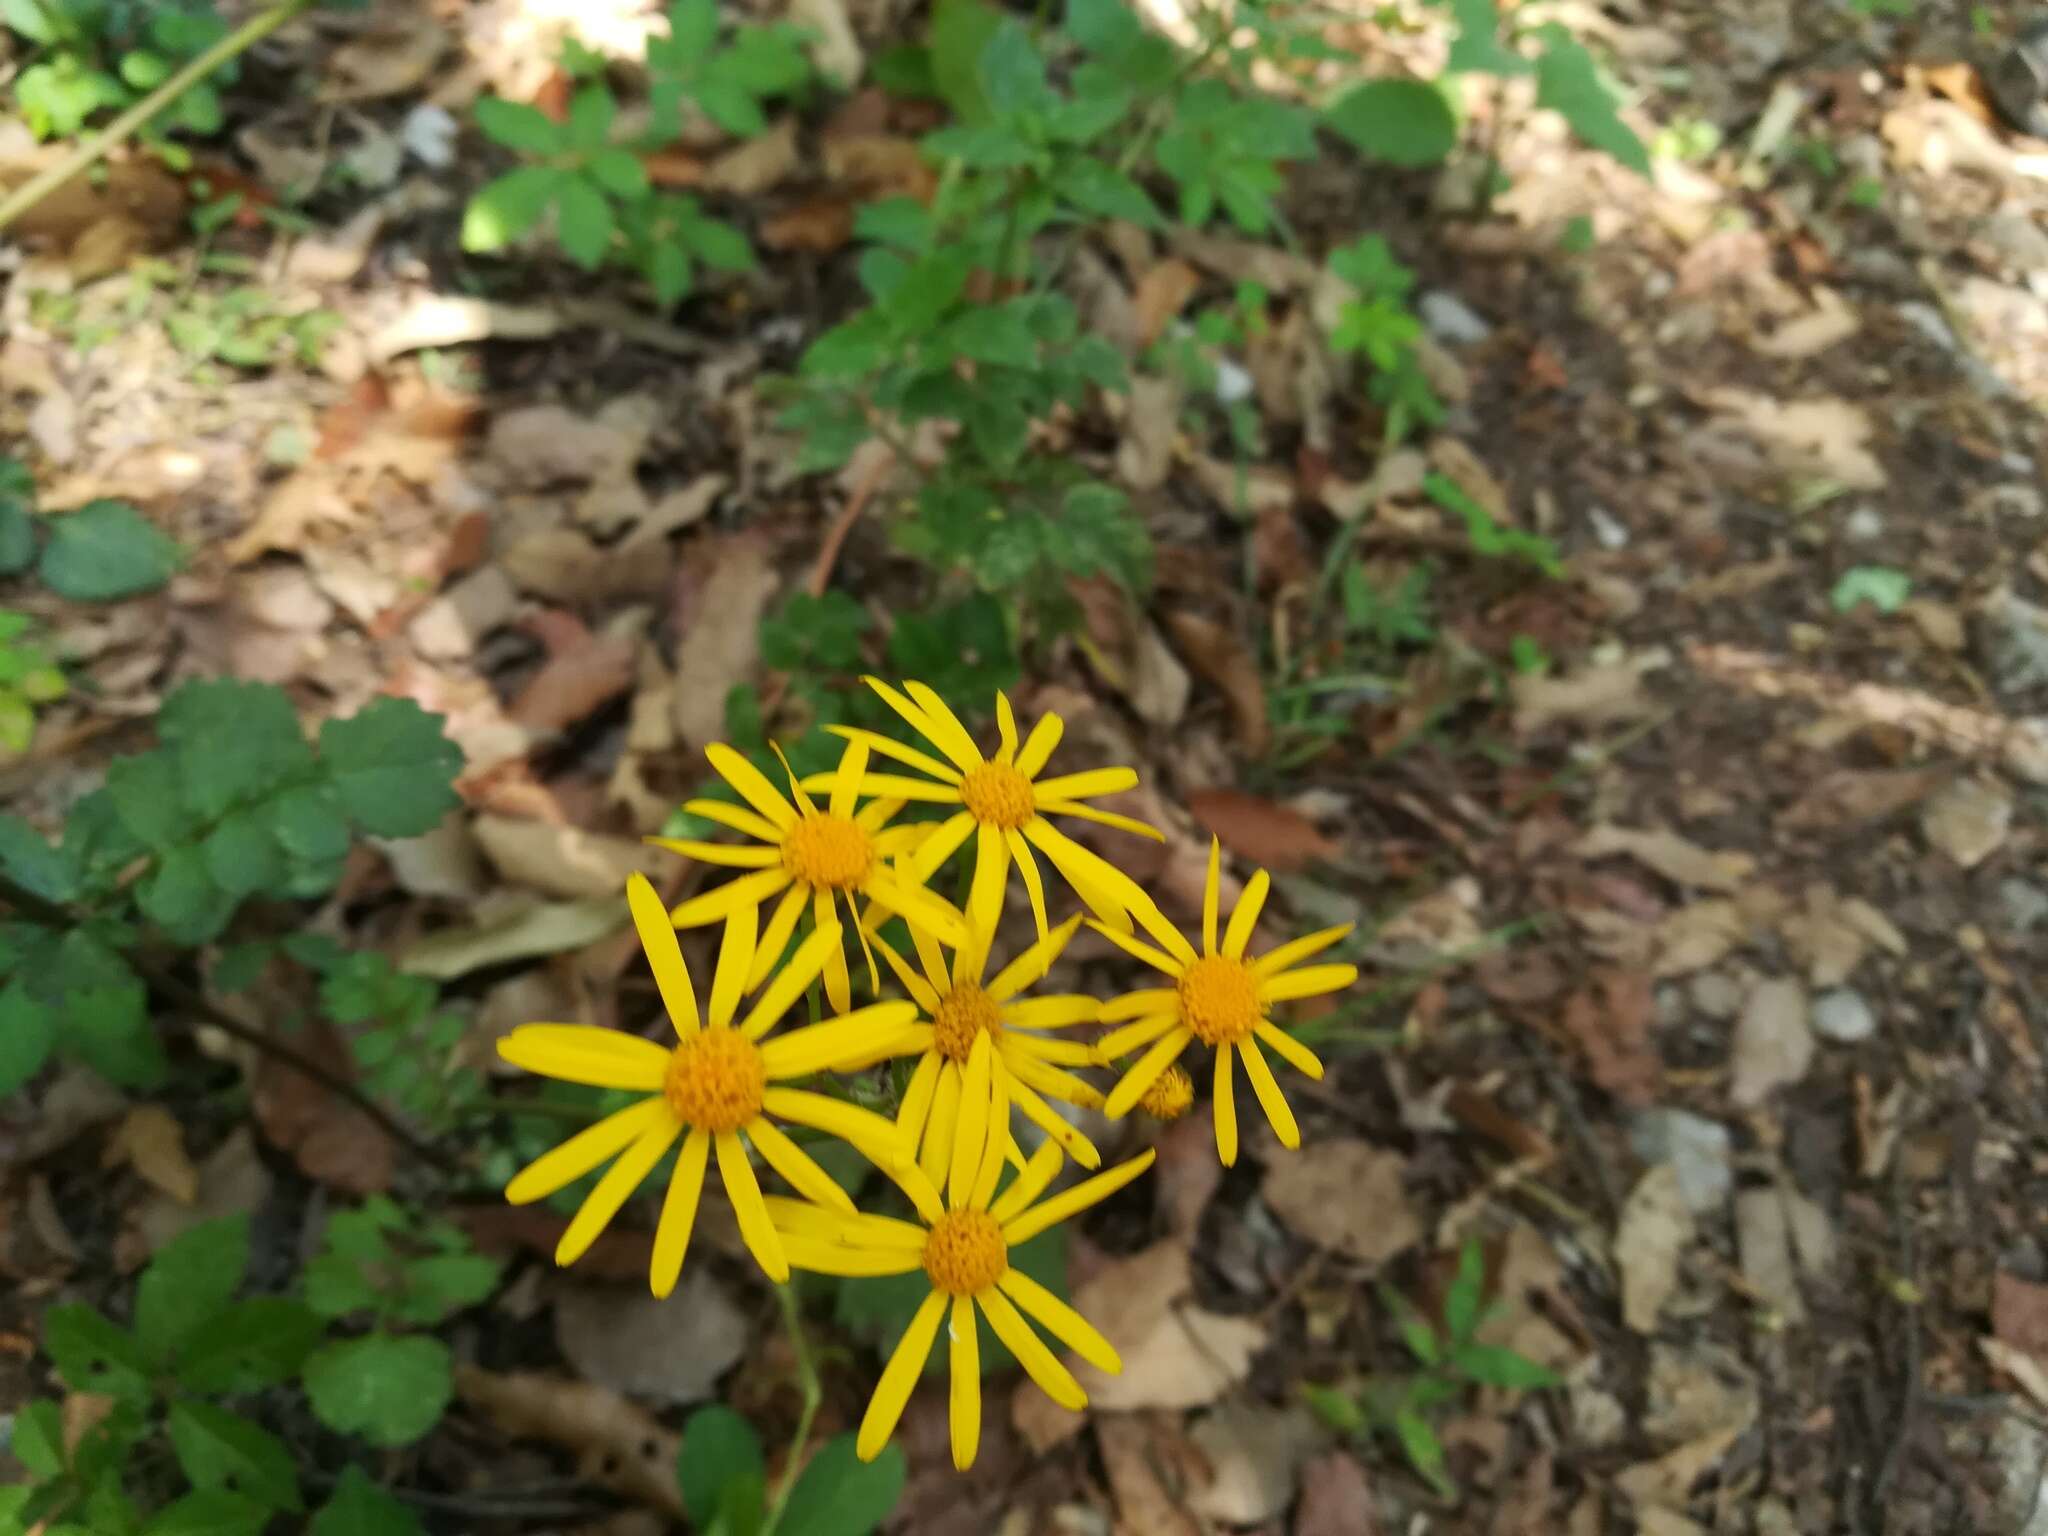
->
[498,678,1358,1468]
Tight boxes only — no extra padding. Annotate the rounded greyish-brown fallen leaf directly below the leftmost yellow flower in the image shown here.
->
[555,1266,750,1403]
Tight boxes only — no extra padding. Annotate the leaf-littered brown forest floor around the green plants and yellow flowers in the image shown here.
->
[0,0,2048,1536]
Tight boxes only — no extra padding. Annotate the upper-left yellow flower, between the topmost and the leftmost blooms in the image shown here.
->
[649,741,967,1012]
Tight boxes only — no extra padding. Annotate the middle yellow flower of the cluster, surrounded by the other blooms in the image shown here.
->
[874,918,1106,1184]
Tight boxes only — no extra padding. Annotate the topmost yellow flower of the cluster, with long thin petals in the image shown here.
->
[805,678,1165,942]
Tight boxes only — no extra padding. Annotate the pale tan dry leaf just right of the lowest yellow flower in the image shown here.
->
[1069,1239,1266,1413]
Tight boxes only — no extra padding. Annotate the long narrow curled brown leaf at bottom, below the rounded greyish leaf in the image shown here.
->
[455,1366,684,1520]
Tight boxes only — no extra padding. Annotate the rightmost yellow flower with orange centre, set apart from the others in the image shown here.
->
[1096,840,1358,1167]
